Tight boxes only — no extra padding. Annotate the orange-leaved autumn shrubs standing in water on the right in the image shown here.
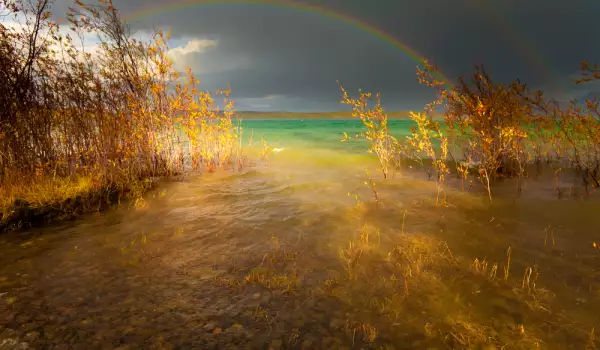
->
[341,62,600,204]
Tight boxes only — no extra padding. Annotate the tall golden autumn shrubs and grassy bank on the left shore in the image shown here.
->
[0,0,246,228]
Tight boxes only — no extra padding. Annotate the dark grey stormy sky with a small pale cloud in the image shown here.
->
[44,0,600,112]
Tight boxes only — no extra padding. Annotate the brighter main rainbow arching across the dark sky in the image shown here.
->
[123,0,453,88]
